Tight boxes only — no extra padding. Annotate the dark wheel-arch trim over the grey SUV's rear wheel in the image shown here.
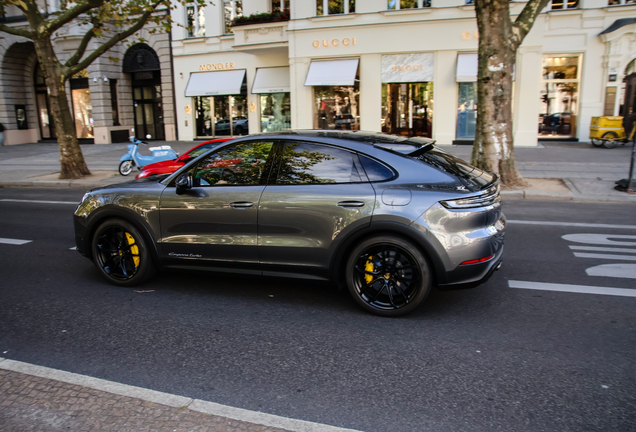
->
[329,221,447,285]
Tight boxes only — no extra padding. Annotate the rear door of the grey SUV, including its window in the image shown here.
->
[258,141,375,270]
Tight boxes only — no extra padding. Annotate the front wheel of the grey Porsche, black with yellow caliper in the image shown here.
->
[91,219,155,287]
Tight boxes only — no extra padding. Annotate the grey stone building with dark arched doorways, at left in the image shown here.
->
[0,0,177,145]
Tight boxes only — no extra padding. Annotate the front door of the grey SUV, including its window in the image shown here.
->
[160,140,274,265]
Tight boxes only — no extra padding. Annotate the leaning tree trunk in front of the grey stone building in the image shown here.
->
[33,38,91,179]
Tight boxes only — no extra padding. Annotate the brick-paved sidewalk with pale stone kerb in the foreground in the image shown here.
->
[0,358,356,432]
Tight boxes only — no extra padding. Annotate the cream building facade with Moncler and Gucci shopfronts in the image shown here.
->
[173,0,636,146]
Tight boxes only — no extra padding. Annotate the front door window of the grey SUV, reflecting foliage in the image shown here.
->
[193,141,274,186]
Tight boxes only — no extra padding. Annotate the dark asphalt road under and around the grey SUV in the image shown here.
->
[0,189,636,432]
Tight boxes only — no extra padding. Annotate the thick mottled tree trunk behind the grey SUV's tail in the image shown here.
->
[472,0,526,186]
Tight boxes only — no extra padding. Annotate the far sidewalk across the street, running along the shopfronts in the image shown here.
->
[0,141,636,202]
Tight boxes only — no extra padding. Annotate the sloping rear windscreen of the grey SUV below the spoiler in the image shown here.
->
[415,149,495,192]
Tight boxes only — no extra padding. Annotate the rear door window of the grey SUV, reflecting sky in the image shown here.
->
[276,142,361,184]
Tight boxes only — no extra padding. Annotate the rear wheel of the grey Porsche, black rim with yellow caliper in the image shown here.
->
[346,235,431,317]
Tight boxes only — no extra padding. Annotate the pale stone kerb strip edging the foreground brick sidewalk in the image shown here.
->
[0,358,357,432]
